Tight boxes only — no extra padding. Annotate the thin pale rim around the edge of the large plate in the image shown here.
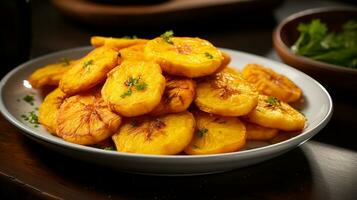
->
[0,46,333,160]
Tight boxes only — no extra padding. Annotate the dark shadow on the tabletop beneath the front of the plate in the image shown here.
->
[24,138,313,199]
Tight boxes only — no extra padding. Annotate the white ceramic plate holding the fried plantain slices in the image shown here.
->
[0,47,332,175]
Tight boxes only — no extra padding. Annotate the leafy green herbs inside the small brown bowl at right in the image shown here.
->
[291,19,357,68]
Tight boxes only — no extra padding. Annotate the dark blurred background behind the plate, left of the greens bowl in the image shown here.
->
[0,0,356,79]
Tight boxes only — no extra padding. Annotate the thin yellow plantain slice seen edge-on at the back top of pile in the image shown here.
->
[90,36,148,50]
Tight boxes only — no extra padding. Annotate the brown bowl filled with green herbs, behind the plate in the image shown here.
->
[273,7,357,90]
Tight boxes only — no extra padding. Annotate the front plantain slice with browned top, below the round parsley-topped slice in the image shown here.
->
[112,111,195,155]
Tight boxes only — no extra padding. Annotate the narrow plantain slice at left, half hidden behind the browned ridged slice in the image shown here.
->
[38,88,68,135]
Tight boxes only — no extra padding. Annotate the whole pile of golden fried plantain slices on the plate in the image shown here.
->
[27,32,306,155]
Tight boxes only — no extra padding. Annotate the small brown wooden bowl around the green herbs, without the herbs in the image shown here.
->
[273,7,357,91]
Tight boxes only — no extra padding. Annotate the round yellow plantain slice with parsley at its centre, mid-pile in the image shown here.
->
[102,60,165,117]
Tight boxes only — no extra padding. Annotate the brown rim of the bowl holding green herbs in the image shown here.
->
[273,6,357,75]
